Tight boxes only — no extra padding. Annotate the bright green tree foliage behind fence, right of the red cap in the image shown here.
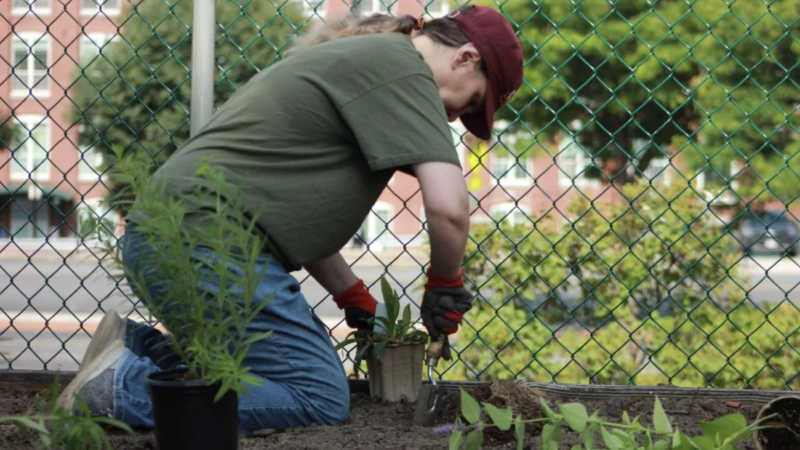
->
[503,0,800,192]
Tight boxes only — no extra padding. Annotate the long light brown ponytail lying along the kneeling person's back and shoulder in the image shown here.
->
[289,6,484,61]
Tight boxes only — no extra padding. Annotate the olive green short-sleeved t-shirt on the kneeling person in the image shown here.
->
[142,33,459,271]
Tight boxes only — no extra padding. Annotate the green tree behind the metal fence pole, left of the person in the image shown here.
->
[72,0,306,160]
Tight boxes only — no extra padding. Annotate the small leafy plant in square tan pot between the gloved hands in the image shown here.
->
[336,278,428,402]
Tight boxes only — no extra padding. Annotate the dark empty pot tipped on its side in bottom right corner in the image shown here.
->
[755,396,800,450]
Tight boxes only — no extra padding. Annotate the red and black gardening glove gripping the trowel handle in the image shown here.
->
[420,269,473,361]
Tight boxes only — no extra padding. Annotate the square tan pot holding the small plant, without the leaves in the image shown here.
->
[365,343,425,403]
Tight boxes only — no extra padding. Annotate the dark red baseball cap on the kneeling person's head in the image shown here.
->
[445,6,523,140]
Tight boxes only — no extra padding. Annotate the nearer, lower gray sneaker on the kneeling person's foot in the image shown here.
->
[56,339,125,415]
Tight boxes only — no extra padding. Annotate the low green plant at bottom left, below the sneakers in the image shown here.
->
[0,375,133,450]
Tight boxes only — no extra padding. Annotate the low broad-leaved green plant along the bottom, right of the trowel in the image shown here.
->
[444,388,775,450]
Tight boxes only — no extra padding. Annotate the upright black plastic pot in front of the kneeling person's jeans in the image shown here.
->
[147,369,239,450]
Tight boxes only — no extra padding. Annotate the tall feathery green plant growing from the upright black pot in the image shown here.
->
[101,146,272,401]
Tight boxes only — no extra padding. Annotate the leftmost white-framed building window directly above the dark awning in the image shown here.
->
[11,115,50,181]
